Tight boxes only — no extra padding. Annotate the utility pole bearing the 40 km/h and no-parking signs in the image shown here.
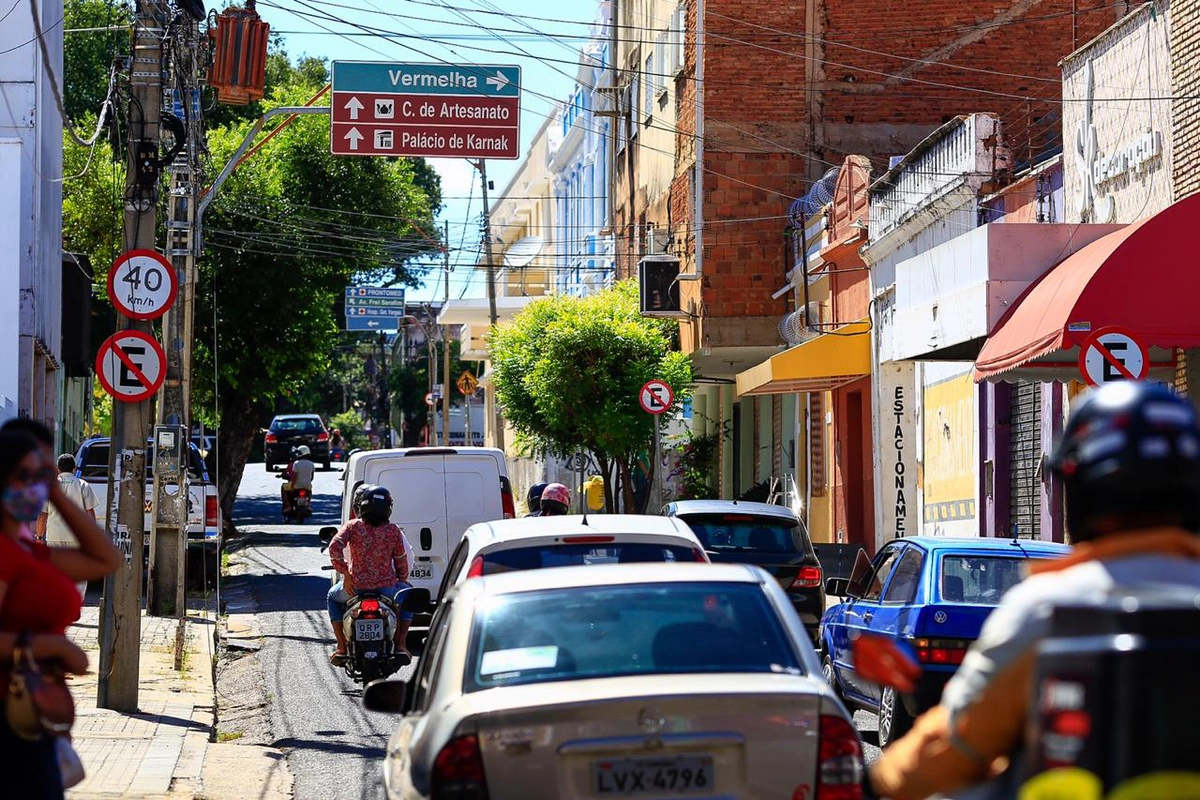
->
[96,0,167,712]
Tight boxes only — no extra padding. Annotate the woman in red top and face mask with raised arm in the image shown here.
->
[0,432,122,800]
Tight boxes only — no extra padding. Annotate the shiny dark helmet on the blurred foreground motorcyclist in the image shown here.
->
[1050,381,1200,541]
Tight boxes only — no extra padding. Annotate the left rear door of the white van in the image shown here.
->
[364,455,450,595]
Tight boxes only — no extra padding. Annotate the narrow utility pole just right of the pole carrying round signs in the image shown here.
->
[146,9,204,618]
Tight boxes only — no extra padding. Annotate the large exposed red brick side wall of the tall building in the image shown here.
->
[672,0,1115,340]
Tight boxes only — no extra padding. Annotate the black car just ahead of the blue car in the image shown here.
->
[662,500,826,642]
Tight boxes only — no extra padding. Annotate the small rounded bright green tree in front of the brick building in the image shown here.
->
[488,281,691,511]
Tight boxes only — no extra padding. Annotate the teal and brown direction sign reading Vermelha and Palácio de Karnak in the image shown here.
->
[330,61,521,160]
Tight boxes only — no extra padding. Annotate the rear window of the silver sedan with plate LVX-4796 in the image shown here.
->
[463,583,804,692]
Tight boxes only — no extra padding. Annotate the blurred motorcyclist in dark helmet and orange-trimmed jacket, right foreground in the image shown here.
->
[856,383,1200,800]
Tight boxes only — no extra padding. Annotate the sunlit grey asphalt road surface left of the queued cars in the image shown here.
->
[234,464,413,798]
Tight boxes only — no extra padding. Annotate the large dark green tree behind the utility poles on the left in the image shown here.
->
[193,62,440,518]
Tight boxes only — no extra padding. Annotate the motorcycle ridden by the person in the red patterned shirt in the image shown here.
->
[319,528,412,686]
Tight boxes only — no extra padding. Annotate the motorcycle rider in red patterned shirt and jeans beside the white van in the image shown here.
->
[326,486,413,667]
